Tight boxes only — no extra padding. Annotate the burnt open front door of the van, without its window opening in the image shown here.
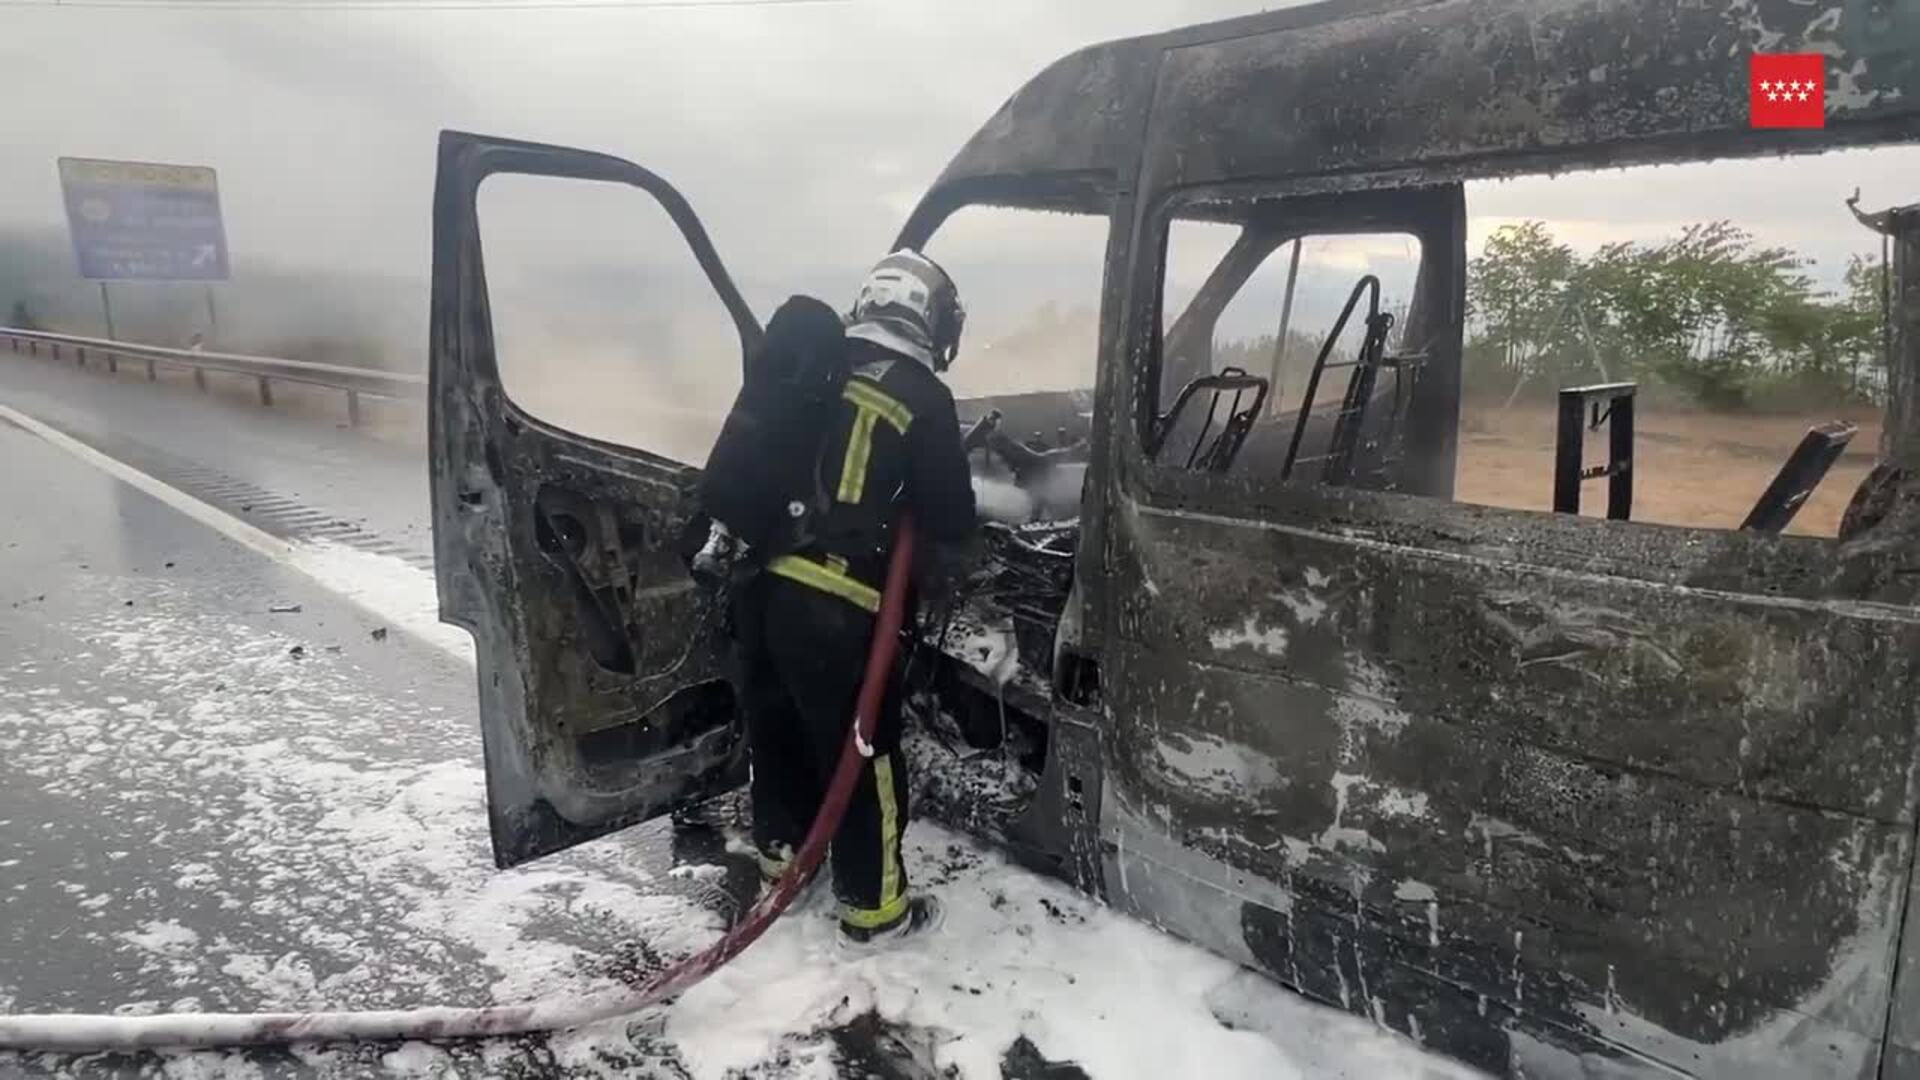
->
[428,131,760,867]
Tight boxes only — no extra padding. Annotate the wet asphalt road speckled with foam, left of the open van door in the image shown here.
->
[0,365,768,1076]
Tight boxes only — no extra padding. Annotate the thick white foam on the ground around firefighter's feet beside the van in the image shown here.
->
[666,824,1473,1080]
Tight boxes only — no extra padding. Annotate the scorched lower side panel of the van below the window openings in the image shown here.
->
[1102,490,1920,1076]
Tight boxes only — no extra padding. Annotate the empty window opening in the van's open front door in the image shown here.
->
[478,175,741,465]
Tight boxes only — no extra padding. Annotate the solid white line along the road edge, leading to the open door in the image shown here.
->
[0,404,474,663]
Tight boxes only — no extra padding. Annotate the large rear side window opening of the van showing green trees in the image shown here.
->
[1457,156,1914,536]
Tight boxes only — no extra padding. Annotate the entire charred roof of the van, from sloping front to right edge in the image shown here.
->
[913,0,1920,206]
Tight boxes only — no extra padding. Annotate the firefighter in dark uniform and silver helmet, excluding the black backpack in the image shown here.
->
[735,250,975,944]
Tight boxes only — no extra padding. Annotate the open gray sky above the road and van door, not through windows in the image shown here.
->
[0,0,1256,282]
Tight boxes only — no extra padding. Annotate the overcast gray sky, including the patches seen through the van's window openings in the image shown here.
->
[0,0,1920,411]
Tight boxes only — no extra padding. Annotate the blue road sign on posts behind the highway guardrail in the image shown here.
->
[60,158,227,281]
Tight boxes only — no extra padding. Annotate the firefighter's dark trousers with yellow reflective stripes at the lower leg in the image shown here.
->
[735,575,906,928]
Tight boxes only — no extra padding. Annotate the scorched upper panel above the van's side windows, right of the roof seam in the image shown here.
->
[1140,0,1920,190]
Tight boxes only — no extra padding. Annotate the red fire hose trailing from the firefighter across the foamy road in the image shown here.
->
[0,517,914,1051]
